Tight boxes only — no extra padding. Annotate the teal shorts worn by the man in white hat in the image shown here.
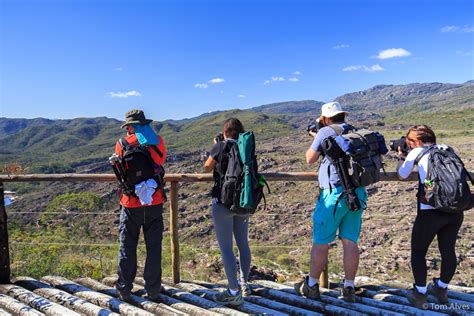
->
[313,187,367,245]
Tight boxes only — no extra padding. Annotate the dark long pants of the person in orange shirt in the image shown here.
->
[116,204,163,295]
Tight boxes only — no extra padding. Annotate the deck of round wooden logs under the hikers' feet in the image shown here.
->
[0,276,474,315]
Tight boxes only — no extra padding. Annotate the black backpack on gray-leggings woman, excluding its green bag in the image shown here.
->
[213,141,270,215]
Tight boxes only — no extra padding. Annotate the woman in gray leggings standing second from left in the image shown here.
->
[204,118,251,305]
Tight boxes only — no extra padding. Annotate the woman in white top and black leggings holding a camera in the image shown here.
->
[397,125,464,309]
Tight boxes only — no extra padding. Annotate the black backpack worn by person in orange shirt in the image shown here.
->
[119,138,166,199]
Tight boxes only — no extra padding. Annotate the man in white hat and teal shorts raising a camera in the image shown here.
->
[295,102,367,302]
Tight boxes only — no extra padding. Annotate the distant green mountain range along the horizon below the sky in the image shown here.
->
[0,80,474,172]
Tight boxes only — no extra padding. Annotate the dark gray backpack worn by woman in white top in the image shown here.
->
[415,146,474,214]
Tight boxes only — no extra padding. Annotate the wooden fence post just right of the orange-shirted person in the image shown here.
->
[170,181,181,284]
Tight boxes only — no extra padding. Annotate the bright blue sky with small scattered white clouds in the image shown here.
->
[0,0,474,120]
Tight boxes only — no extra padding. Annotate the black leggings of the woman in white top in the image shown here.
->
[411,210,464,286]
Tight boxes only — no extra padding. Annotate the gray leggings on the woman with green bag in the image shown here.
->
[212,201,250,289]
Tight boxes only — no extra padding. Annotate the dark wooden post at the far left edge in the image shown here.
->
[0,181,10,284]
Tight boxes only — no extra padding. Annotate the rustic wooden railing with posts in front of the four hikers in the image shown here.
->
[0,172,432,288]
